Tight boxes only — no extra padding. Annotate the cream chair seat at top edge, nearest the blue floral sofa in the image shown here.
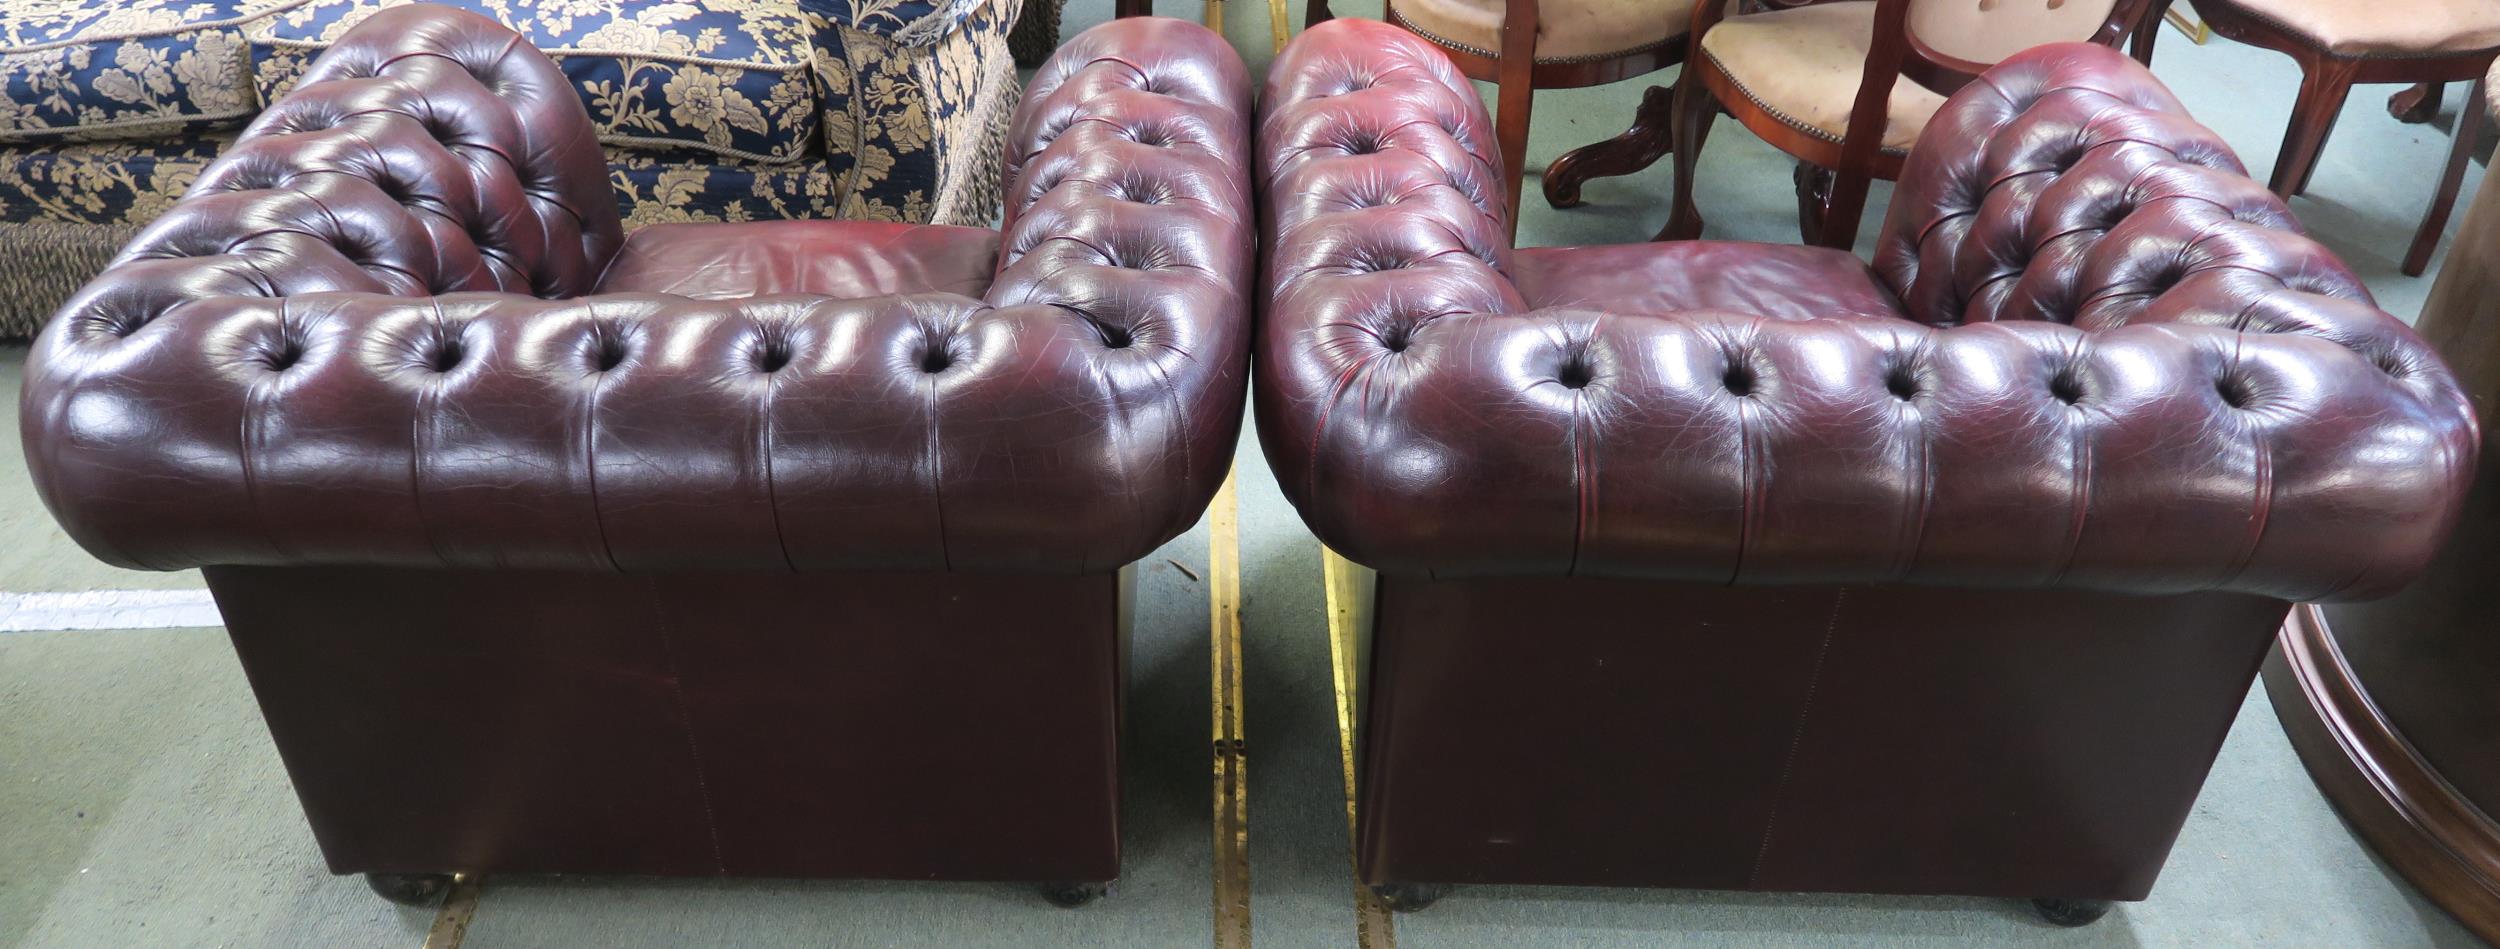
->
[1390,0,1693,62]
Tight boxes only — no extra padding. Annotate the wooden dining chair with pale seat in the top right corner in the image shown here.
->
[2133,0,2500,277]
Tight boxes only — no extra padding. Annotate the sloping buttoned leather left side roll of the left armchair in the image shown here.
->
[65,5,623,352]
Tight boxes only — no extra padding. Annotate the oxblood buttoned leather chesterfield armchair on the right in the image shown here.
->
[1258,20,2478,924]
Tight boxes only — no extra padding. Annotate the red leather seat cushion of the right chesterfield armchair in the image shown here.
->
[1510,240,1903,320]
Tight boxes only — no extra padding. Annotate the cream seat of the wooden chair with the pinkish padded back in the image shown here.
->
[1703,0,1945,152]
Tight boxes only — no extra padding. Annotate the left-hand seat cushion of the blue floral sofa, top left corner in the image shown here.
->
[0,0,305,142]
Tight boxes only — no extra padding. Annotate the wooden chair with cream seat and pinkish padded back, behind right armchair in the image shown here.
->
[1658,0,2145,247]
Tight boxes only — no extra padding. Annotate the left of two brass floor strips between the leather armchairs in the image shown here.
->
[1208,472,1250,949]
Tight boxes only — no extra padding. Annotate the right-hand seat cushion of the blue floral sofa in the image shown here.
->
[250,0,823,162]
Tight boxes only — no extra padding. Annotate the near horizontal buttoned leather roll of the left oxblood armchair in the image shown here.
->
[23,292,1240,572]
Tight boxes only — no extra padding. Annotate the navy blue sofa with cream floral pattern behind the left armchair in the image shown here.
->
[0,0,1020,337]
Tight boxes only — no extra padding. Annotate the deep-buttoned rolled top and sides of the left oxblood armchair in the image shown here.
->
[23,7,1250,572]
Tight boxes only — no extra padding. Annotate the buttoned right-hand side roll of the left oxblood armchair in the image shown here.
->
[990,17,1258,537]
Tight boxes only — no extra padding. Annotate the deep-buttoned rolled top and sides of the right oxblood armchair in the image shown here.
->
[1258,20,2478,599]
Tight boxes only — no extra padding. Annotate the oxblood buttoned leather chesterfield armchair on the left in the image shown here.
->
[23,7,1253,899]
